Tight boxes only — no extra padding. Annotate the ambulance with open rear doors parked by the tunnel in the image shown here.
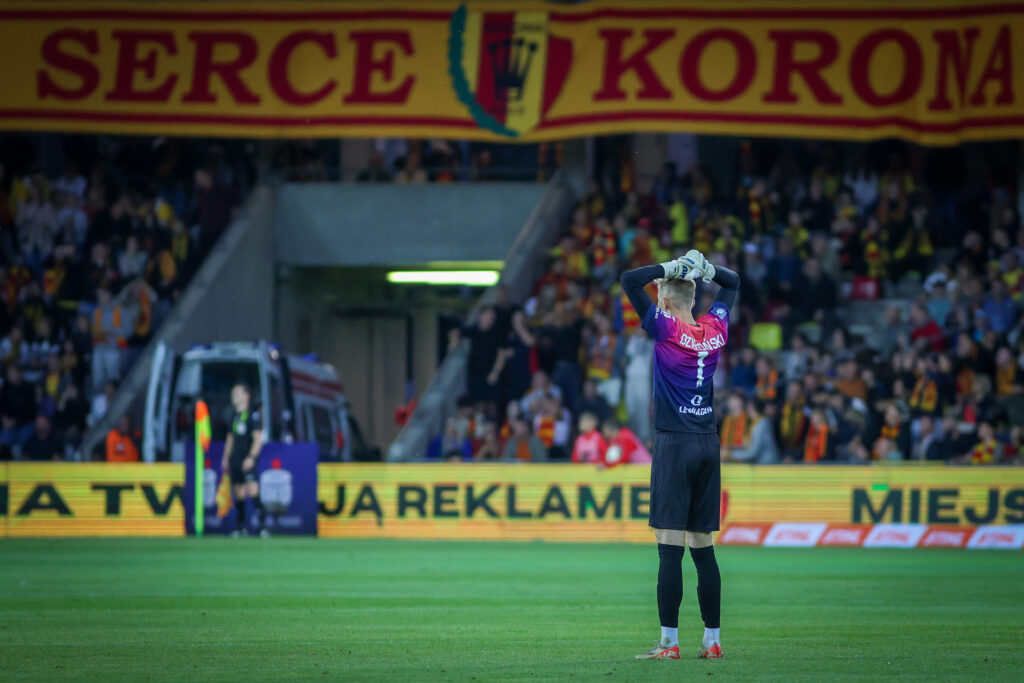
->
[142,341,380,462]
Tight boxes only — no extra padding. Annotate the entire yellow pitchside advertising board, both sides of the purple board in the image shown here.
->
[0,463,1024,542]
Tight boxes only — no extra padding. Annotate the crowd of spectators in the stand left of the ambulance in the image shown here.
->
[0,136,243,461]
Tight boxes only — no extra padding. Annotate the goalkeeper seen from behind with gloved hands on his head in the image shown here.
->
[622,249,739,659]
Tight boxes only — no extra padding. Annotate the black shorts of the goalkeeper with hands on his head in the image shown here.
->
[649,431,722,531]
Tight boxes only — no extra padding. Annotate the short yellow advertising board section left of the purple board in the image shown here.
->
[0,463,184,538]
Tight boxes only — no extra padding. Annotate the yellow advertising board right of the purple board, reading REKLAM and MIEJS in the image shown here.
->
[318,464,1024,542]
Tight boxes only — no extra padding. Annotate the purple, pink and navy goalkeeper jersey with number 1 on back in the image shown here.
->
[643,301,729,433]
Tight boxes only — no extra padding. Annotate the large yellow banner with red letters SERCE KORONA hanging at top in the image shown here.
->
[0,0,1024,144]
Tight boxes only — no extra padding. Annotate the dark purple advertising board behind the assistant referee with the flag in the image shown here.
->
[183,441,318,536]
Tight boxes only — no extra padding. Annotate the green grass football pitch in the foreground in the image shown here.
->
[0,539,1024,681]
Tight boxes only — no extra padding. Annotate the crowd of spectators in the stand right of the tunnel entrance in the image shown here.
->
[442,141,1024,466]
